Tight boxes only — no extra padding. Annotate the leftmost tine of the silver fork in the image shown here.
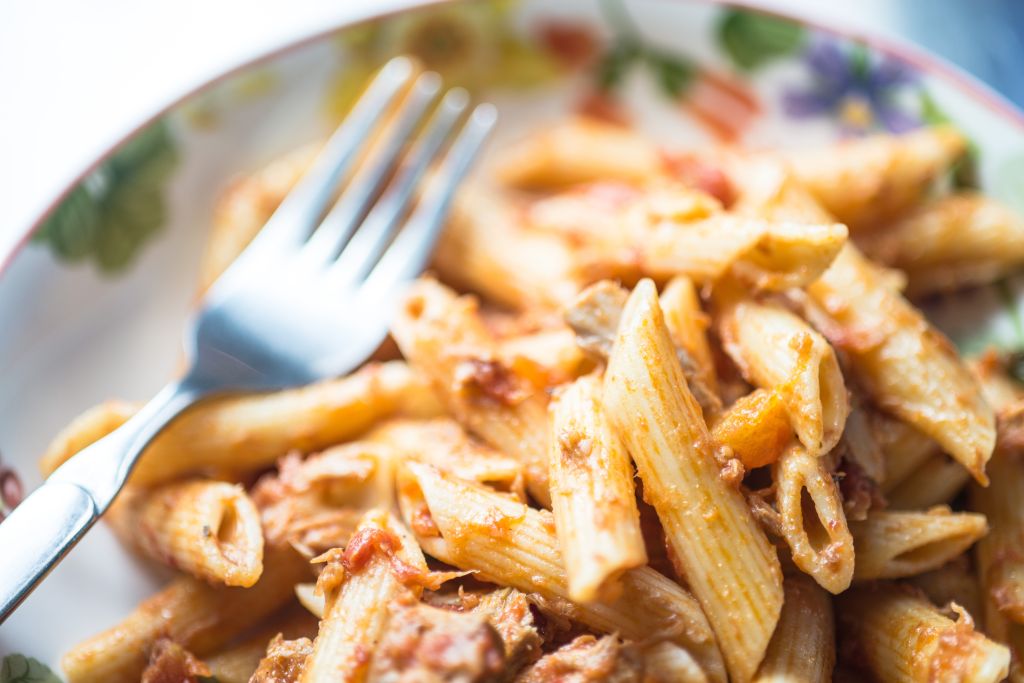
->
[229,57,415,260]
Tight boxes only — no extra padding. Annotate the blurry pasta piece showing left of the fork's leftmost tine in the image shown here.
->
[200,144,319,292]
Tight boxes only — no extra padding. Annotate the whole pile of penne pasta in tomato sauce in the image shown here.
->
[43,119,1024,683]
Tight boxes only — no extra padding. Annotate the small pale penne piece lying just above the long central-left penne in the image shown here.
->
[367,418,522,490]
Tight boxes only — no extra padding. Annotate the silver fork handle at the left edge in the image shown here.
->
[0,381,204,624]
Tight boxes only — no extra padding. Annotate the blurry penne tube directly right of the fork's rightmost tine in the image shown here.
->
[433,182,584,310]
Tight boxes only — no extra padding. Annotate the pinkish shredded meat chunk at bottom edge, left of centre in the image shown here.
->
[368,603,505,683]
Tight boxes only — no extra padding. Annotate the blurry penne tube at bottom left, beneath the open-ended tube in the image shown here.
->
[61,548,310,683]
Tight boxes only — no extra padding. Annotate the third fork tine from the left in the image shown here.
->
[328,88,469,289]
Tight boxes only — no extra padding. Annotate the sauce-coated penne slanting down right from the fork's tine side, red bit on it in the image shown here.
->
[391,280,551,505]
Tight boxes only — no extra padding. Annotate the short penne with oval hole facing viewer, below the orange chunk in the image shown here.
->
[772,444,860,594]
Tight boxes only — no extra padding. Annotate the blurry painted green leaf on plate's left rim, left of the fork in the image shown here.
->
[33,121,178,273]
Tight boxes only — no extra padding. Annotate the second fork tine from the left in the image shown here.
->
[300,72,441,268]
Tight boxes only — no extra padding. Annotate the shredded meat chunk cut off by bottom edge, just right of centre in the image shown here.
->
[516,636,643,683]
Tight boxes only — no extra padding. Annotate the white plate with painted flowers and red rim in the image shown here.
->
[0,0,1024,671]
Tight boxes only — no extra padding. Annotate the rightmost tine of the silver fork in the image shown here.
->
[360,104,498,301]
